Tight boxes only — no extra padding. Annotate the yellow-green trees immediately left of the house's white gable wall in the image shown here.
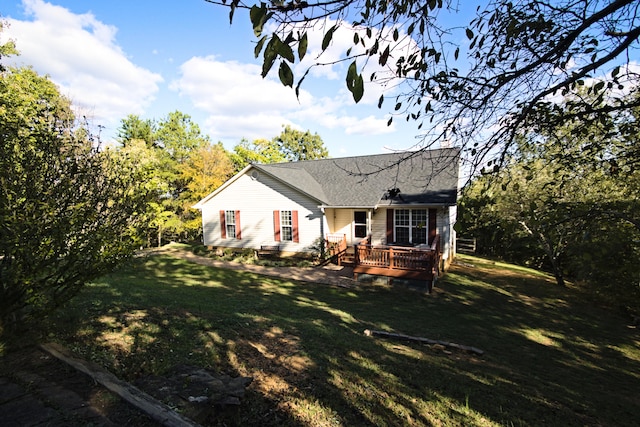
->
[118,111,232,246]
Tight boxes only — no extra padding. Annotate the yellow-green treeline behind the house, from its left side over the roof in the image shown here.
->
[110,111,329,246]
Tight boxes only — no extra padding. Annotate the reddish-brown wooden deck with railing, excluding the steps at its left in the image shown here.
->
[353,235,442,292]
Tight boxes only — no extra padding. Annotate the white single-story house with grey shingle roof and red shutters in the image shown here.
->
[195,148,460,265]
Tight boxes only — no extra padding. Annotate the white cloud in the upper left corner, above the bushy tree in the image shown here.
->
[7,0,162,124]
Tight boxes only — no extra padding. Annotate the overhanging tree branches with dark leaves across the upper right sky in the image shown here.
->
[206,0,640,171]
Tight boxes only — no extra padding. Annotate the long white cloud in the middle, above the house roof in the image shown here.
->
[170,56,393,141]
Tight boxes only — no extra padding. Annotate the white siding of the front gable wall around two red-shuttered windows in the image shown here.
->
[202,173,323,252]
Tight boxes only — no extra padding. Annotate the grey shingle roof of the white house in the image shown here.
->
[253,148,460,207]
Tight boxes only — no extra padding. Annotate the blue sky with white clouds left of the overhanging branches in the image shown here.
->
[0,0,448,157]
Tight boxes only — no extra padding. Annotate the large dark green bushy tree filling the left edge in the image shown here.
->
[0,68,146,330]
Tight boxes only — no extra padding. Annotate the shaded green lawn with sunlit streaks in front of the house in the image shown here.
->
[48,252,640,426]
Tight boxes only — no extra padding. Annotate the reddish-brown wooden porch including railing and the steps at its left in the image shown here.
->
[326,235,442,292]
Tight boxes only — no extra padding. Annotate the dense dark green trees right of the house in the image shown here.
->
[457,89,640,313]
